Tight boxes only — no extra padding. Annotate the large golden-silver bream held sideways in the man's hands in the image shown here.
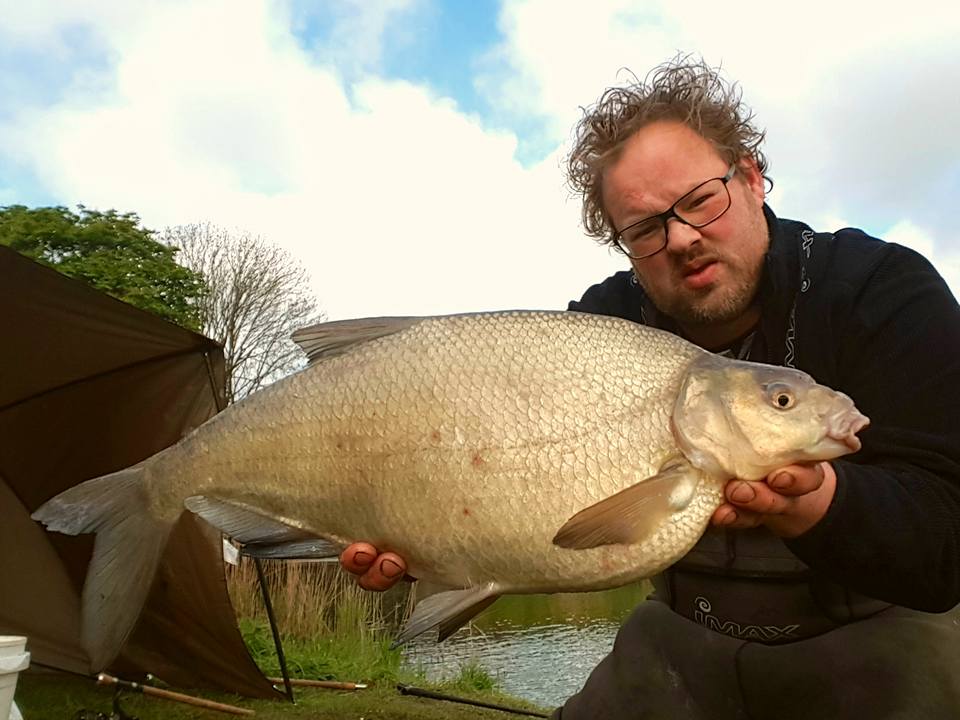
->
[34,312,867,667]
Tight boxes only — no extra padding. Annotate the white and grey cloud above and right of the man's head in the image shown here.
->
[478,0,960,290]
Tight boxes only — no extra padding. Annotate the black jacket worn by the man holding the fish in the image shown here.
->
[569,207,960,612]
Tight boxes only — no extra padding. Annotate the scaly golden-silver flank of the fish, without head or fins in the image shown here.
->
[162,313,709,592]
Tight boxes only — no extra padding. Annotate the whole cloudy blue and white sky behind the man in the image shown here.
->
[0,0,960,320]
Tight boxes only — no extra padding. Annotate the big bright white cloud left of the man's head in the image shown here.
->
[0,2,622,318]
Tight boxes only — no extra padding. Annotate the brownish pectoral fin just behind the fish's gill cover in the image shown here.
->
[553,459,700,550]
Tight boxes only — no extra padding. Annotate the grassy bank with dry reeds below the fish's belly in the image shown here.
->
[17,560,543,720]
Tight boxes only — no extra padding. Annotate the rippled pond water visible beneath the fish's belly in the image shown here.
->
[405,584,650,707]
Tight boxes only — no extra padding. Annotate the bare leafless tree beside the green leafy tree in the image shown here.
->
[163,223,320,402]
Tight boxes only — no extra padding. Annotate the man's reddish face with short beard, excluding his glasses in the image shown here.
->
[603,122,769,339]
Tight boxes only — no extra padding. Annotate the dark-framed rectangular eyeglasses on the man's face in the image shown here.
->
[613,165,737,260]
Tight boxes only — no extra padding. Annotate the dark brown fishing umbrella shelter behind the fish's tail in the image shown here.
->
[0,246,277,697]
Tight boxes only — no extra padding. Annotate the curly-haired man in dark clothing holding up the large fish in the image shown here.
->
[342,60,960,720]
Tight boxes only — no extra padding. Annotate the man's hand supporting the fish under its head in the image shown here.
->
[711,462,837,537]
